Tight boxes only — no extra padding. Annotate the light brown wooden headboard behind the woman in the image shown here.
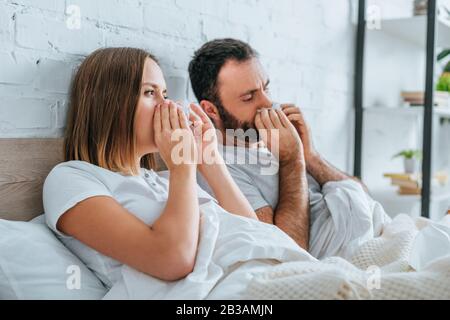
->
[0,138,166,221]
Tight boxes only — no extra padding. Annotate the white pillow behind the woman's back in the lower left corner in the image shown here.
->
[0,216,107,300]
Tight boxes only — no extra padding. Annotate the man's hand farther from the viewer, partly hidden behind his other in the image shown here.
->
[281,104,319,164]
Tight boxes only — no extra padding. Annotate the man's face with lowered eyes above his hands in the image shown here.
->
[218,58,272,130]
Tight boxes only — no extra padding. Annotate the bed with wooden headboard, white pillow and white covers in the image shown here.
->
[0,138,450,299]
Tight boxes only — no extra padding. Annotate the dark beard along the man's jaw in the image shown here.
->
[216,103,260,143]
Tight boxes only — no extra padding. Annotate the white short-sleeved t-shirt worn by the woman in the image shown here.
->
[43,161,214,288]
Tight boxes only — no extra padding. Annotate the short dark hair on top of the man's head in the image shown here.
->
[189,39,258,106]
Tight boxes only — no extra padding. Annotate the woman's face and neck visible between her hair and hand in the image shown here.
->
[135,58,167,157]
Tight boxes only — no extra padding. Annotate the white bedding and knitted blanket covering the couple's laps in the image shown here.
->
[104,180,450,299]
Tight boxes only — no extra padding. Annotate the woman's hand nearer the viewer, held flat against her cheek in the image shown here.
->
[153,100,198,171]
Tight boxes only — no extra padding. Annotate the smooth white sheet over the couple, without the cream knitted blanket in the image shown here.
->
[104,180,450,300]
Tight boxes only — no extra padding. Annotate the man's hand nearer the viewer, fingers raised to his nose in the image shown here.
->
[255,109,304,163]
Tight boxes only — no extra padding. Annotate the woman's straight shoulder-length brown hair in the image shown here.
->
[64,48,157,175]
